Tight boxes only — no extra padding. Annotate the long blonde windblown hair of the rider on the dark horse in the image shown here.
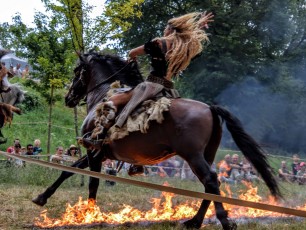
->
[163,12,209,79]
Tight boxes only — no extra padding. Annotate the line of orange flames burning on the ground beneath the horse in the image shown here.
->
[34,182,306,228]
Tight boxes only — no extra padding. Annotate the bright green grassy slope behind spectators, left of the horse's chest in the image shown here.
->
[0,84,85,154]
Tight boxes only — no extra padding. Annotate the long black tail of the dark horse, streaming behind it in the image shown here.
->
[210,105,281,197]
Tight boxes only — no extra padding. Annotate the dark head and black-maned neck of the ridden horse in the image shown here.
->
[65,52,143,107]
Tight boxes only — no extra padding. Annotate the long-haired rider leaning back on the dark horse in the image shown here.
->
[80,12,213,174]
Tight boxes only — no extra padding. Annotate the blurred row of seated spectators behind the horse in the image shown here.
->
[6,139,306,185]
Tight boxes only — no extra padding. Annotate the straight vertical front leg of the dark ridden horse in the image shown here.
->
[88,151,104,200]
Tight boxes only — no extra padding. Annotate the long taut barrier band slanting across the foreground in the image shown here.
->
[0,151,306,217]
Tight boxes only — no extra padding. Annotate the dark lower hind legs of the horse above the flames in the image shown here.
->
[184,158,237,230]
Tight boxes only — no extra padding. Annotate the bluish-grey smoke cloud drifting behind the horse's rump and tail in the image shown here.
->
[216,78,306,155]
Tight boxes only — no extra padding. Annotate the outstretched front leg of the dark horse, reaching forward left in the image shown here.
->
[32,155,88,206]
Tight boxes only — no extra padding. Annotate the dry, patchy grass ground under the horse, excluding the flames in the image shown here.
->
[0,164,306,230]
